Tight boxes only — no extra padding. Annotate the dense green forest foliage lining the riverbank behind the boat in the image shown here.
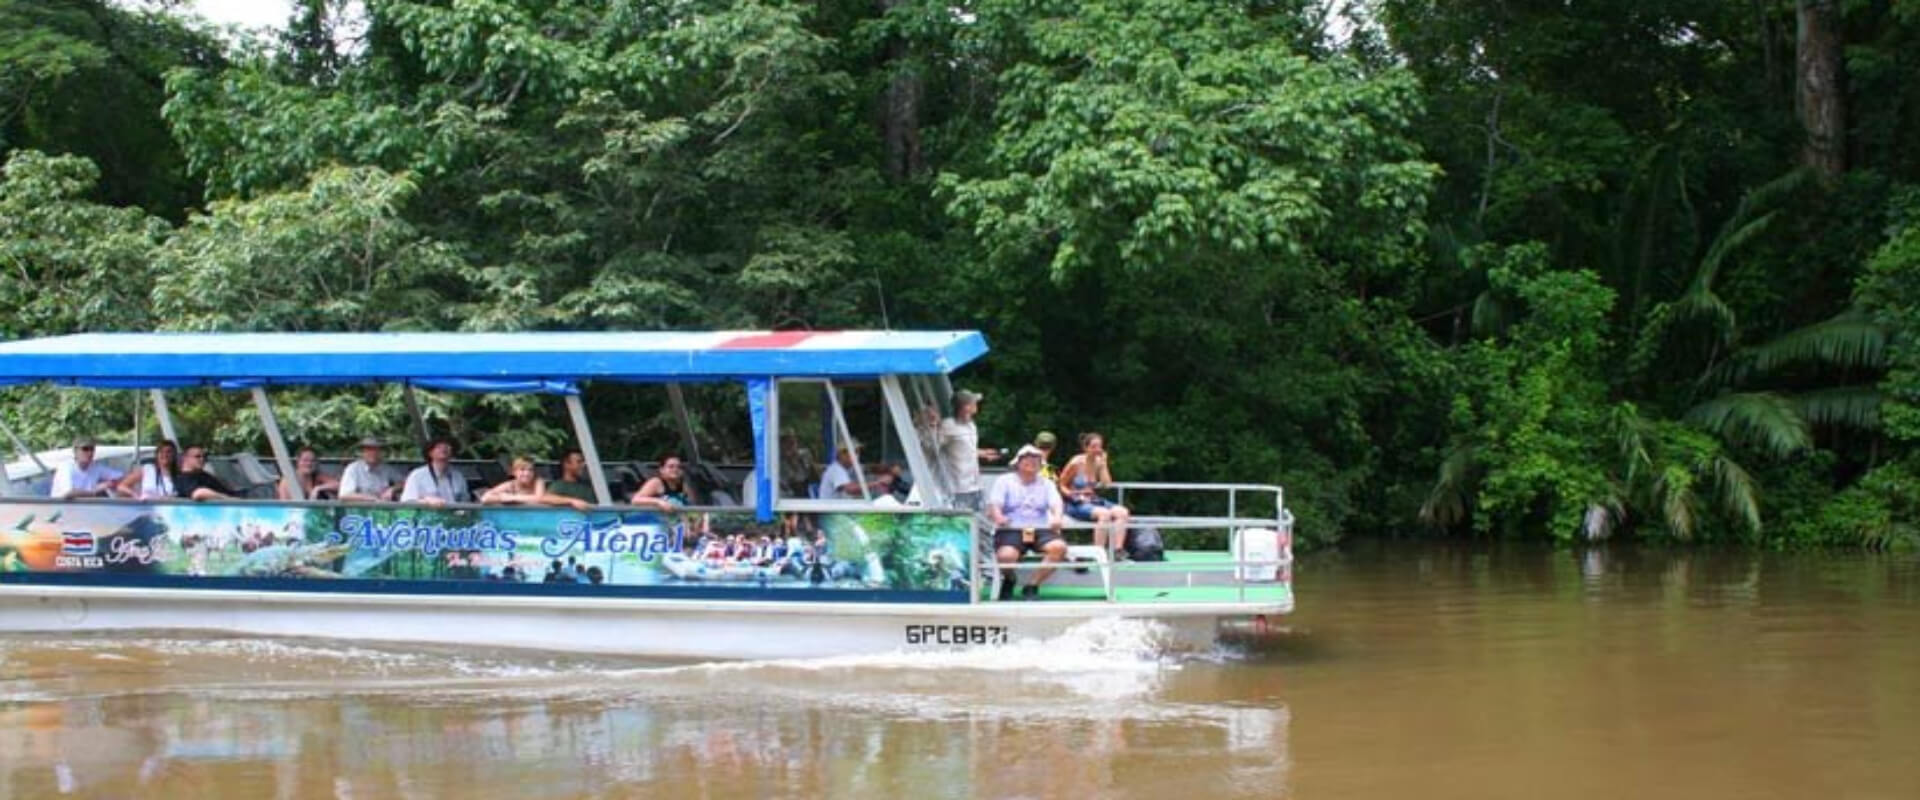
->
[0,0,1920,547]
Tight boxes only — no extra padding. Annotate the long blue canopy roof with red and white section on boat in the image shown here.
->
[0,330,987,393]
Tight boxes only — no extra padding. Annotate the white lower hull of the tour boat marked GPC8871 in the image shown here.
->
[0,585,1290,660]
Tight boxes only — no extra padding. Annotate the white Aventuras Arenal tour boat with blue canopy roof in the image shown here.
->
[0,332,1292,658]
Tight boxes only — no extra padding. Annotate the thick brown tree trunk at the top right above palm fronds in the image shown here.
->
[1793,0,1847,180]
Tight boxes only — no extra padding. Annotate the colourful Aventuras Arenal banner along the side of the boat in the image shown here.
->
[0,503,970,595]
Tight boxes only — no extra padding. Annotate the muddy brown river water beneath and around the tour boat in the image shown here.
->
[0,543,1920,800]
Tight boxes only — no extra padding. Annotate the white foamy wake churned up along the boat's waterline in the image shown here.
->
[0,620,1221,718]
